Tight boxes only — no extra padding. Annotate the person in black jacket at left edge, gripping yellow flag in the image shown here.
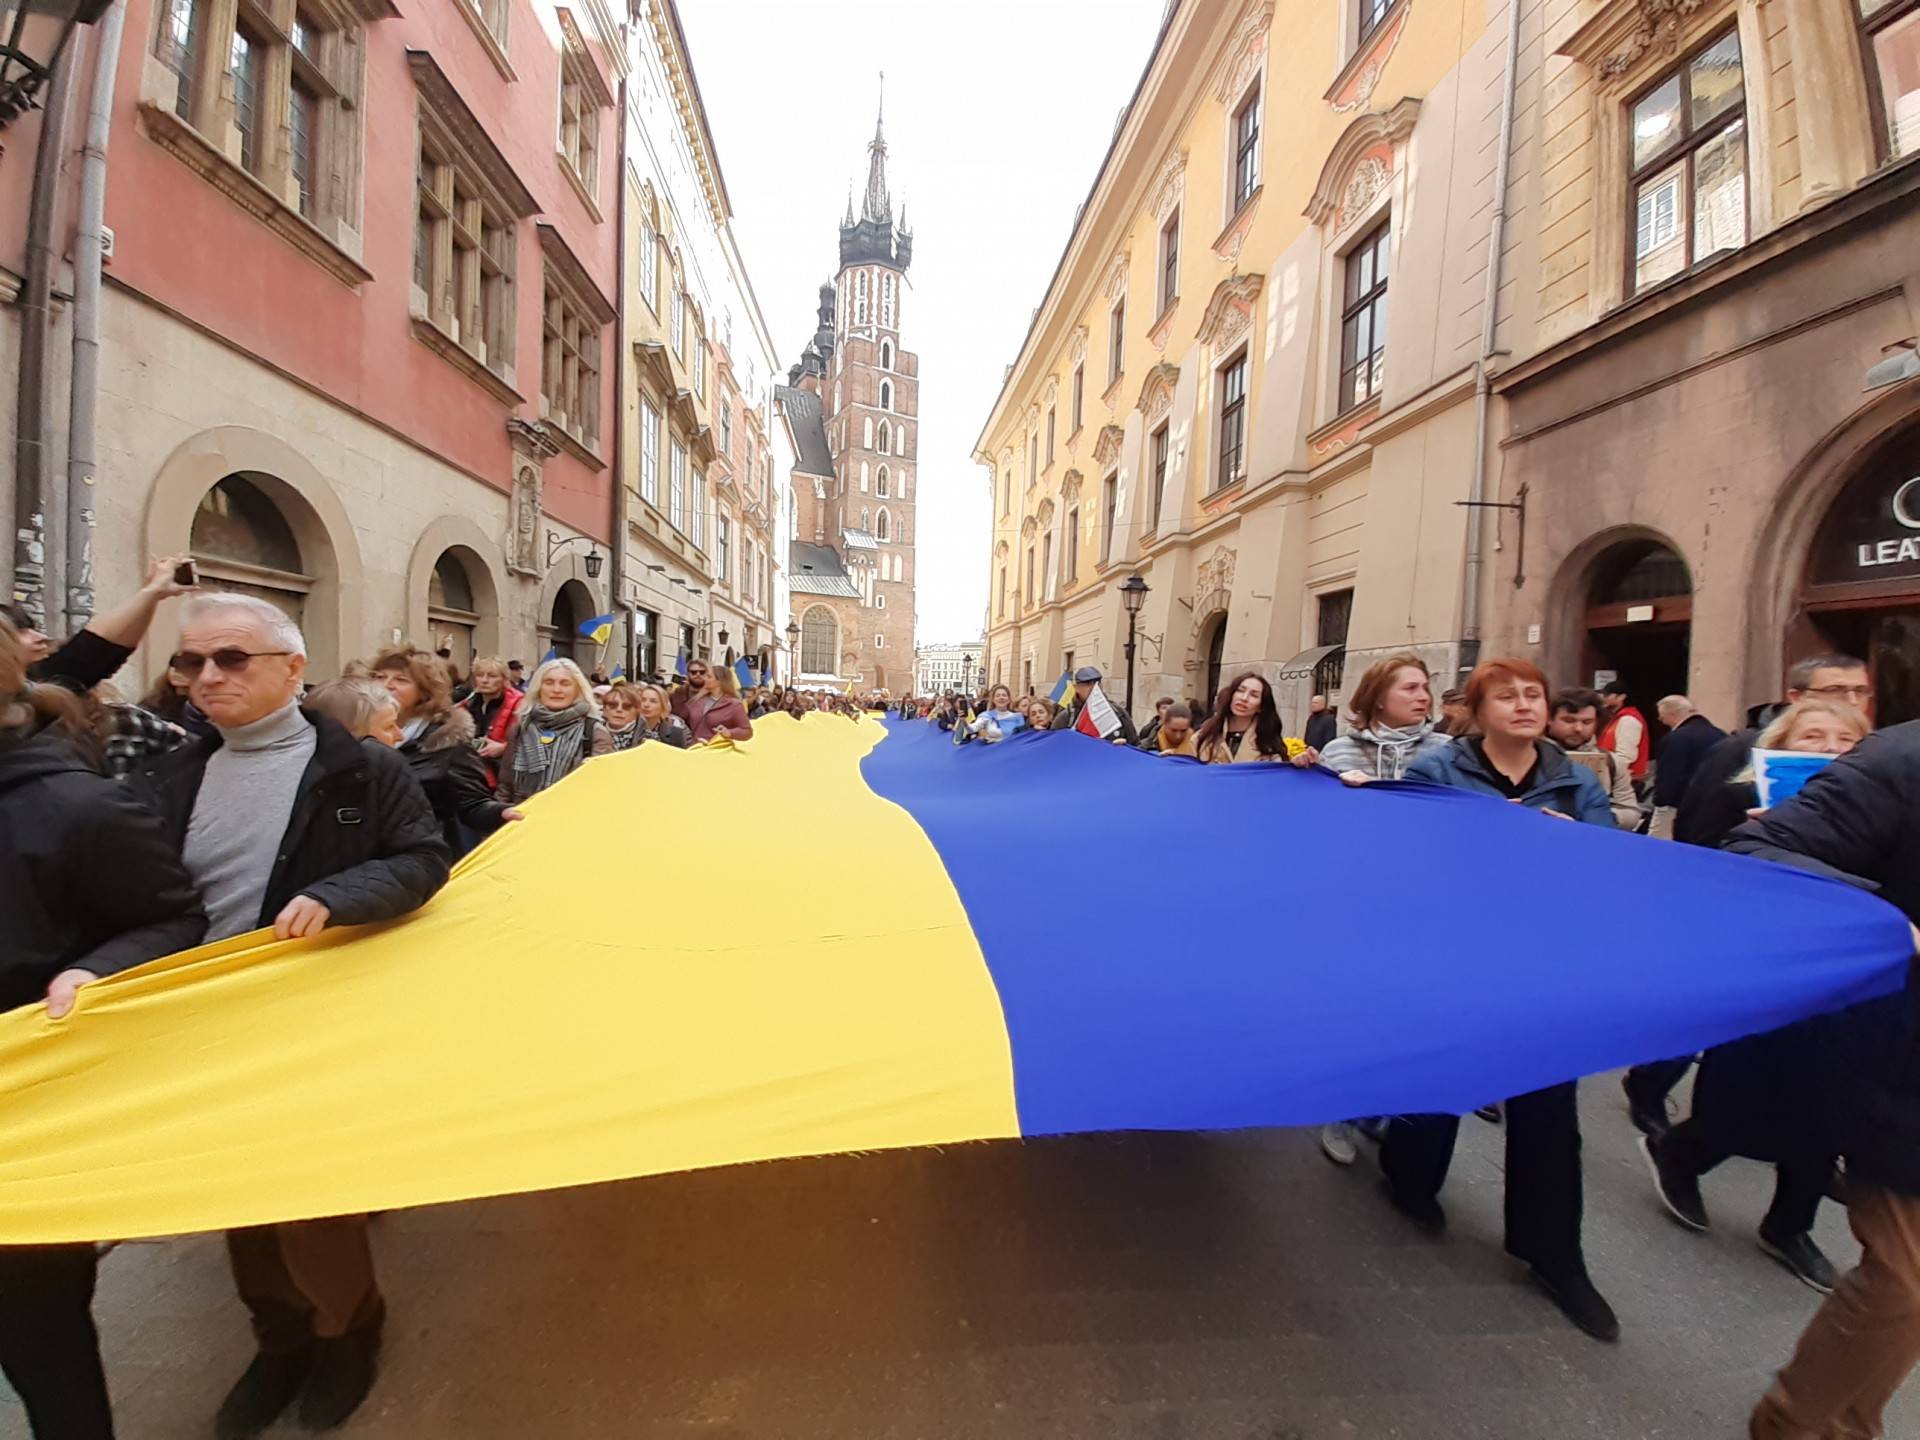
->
[0,618,207,1440]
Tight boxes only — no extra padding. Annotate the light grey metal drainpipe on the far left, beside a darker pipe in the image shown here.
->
[67,0,127,634]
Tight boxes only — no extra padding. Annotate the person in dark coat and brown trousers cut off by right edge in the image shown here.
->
[1726,722,1920,1440]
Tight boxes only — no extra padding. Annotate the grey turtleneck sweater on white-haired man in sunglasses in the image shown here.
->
[184,701,319,941]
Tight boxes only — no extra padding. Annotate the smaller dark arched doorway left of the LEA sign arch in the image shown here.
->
[1582,536,1693,726]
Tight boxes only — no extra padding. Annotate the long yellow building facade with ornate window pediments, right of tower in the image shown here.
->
[975,0,1540,726]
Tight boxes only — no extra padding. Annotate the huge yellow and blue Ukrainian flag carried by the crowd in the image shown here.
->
[0,714,1910,1242]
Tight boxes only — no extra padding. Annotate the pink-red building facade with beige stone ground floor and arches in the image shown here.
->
[0,0,626,682]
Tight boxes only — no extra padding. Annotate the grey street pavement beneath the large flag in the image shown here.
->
[0,1079,1896,1440]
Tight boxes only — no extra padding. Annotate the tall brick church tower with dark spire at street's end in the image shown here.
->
[780,96,920,695]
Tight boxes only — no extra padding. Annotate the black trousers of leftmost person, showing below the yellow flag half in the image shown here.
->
[0,1244,113,1440]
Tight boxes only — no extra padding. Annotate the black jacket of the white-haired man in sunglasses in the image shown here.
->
[136,712,447,925]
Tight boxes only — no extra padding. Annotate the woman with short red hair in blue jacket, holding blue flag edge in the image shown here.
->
[1380,659,1620,1340]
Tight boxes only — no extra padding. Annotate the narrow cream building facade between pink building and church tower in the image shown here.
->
[611,0,789,676]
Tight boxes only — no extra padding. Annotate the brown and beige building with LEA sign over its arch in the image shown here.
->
[1486,0,1920,726]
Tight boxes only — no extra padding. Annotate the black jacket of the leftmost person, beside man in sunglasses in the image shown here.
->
[0,732,207,1010]
